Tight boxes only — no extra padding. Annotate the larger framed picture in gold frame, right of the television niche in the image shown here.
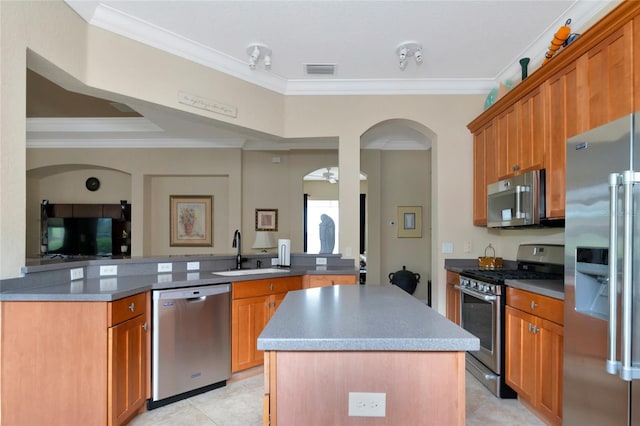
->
[169,195,213,247]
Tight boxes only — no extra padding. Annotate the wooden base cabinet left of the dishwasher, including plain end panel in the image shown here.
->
[0,293,150,425]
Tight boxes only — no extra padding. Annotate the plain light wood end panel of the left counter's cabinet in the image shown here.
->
[0,302,108,425]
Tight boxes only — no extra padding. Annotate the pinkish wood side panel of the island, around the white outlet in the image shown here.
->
[270,351,465,426]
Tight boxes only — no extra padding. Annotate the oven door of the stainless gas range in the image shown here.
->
[459,287,502,375]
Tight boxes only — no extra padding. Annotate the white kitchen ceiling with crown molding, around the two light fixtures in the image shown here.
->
[65,0,609,94]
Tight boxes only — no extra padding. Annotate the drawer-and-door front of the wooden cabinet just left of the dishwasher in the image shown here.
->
[107,294,149,425]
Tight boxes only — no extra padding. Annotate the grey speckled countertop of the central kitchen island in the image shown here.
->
[258,284,480,351]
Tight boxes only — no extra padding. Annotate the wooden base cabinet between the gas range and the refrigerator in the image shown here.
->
[505,288,564,424]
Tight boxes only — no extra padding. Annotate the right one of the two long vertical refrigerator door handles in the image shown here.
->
[620,170,640,381]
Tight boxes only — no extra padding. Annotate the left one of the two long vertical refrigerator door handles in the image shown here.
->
[606,173,621,374]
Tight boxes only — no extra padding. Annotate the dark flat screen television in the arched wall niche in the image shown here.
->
[47,217,113,256]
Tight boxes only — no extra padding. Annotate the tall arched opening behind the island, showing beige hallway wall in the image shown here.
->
[360,119,436,300]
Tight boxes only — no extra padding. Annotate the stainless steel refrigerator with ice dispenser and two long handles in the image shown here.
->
[563,113,640,426]
